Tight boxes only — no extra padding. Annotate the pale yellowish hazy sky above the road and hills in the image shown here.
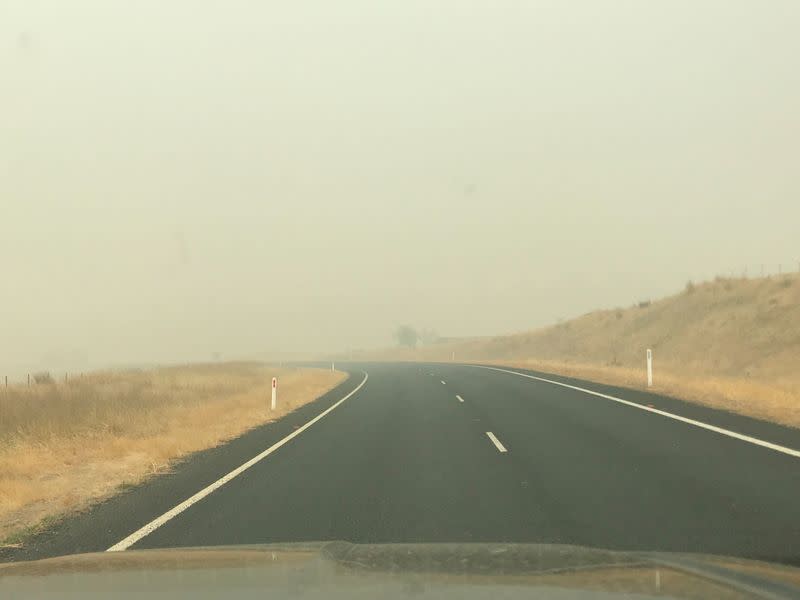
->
[0,0,800,375]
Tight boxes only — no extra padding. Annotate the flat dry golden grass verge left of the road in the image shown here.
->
[0,363,346,539]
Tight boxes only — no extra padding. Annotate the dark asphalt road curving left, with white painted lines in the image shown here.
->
[6,364,800,564]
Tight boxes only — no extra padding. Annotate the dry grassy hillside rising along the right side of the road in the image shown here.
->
[359,275,800,427]
